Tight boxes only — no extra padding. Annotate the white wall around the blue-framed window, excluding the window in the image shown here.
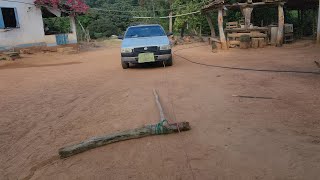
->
[0,0,45,50]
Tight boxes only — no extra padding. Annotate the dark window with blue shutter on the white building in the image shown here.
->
[0,7,19,29]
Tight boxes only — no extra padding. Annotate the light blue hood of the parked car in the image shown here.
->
[121,36,170,48]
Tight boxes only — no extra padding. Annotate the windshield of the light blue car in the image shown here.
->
[125,26,166,38]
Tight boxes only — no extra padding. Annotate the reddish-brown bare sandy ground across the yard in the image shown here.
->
[0,44,320,180]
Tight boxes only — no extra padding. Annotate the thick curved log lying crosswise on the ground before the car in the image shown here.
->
[59,122,191,158]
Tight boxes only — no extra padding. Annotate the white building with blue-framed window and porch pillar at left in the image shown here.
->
[0,0,77,51]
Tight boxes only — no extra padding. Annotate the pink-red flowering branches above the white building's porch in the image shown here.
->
[34,0,89,15]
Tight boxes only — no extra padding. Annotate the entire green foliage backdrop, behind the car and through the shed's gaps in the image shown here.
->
[65,0,315,38]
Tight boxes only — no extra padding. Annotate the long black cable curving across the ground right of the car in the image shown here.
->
[173,45,320,75]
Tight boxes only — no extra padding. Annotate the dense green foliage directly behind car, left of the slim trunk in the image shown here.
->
[77,0,174,38]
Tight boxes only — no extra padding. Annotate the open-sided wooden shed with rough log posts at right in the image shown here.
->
[202,0,320,49]
